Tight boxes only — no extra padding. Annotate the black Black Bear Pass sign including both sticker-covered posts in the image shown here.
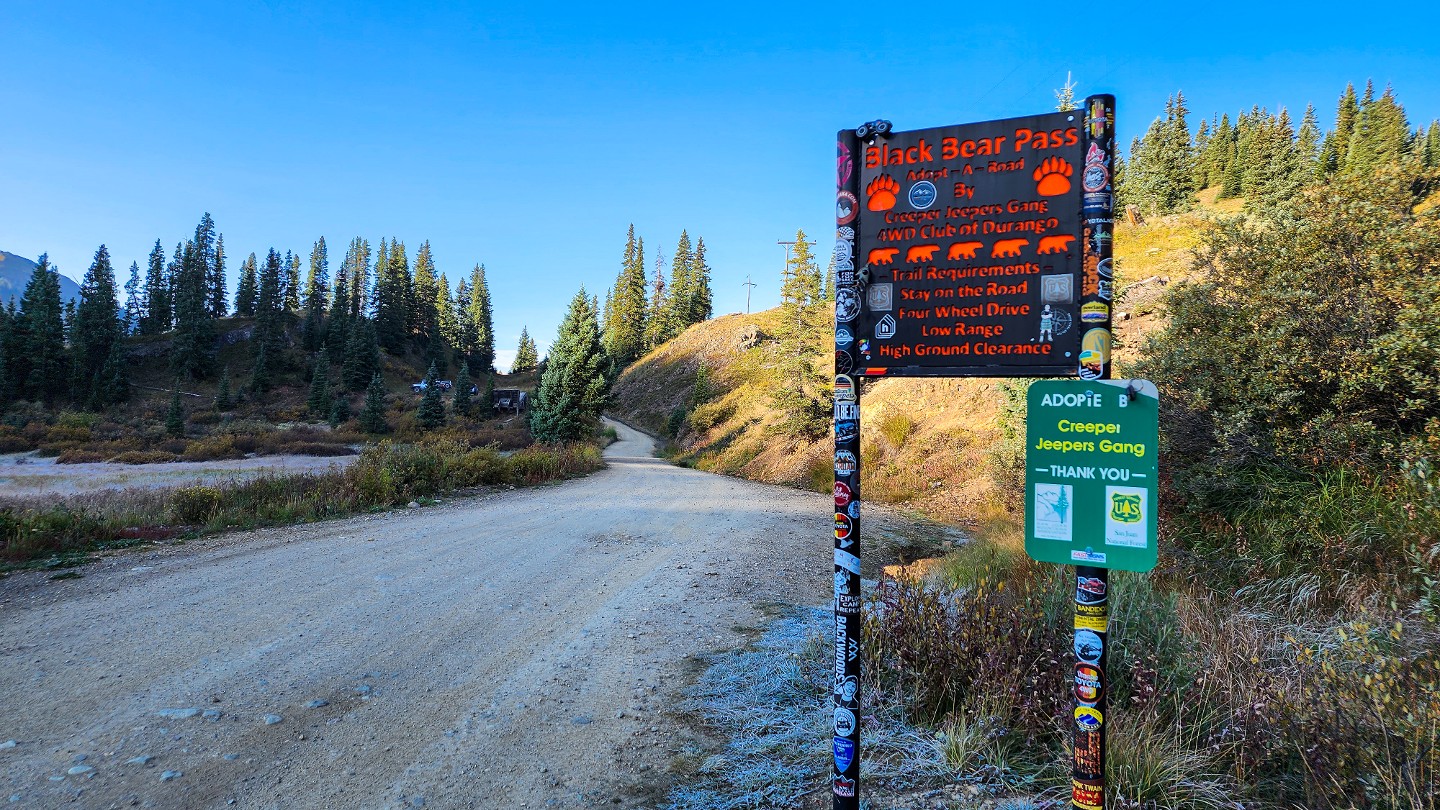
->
[831,95,1134,810]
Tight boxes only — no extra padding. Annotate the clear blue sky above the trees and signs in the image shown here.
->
[0,0,1440,365]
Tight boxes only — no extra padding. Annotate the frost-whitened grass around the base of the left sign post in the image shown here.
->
[670,608,955,810]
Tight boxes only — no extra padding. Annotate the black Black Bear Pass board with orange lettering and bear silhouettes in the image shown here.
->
[837,97,1115,379]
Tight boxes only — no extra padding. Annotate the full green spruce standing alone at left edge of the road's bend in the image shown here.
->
[530,288,609,444]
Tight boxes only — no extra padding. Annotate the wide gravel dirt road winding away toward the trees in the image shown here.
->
[0,425,831,809]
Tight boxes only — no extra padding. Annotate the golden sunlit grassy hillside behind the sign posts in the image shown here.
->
[613,189,1215,528]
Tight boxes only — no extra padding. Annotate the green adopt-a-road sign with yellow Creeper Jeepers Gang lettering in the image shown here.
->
[1025,379,1159,571]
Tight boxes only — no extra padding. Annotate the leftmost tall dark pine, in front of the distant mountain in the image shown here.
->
[12,254,69,405]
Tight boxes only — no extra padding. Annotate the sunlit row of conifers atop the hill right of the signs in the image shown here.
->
[1116,82,1440,213]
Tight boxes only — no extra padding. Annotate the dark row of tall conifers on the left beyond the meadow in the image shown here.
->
[0,213,509,415]
